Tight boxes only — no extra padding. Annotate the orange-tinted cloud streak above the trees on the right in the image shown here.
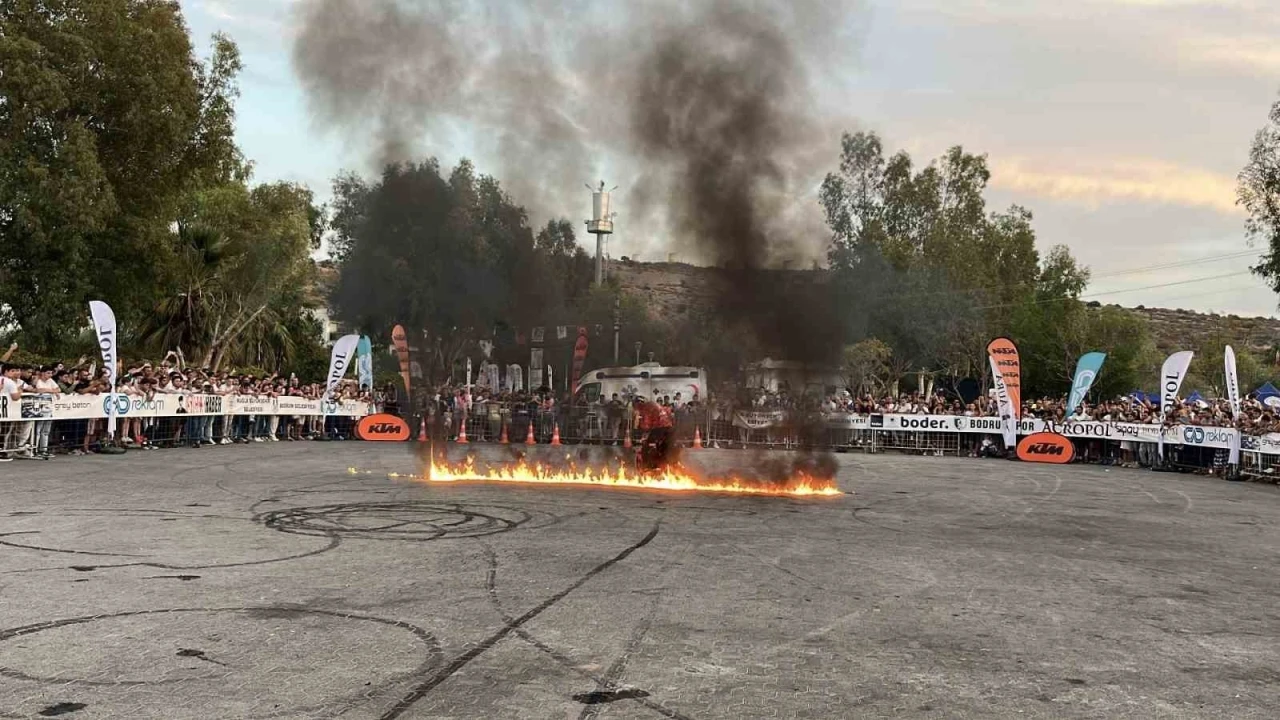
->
[989,158,1240,215]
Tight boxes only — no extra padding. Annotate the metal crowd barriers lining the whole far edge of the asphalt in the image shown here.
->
[0,394,1280,482]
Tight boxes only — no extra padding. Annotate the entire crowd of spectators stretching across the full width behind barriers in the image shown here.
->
[0,335,1280,461]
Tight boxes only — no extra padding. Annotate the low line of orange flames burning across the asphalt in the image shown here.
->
[390,457,845,497]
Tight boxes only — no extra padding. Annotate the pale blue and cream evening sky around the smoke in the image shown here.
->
[182,0,1280,316]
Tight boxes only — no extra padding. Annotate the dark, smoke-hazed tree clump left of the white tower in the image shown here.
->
[330,160,596,379]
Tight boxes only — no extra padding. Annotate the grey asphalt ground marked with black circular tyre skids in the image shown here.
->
[0,443,1280,720]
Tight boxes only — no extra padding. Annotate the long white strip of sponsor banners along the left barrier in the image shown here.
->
[0,392,372,420]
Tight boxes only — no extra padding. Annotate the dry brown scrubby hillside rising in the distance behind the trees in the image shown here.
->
[609,261,1280,351]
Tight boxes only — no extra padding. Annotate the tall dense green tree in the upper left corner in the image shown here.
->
[0,0,242,351]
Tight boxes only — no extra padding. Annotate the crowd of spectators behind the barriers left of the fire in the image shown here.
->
[0,346,373,461]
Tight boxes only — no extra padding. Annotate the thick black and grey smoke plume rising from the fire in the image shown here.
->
[293,0,858,481]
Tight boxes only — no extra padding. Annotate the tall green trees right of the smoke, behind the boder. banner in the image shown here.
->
[819,133,1088,388]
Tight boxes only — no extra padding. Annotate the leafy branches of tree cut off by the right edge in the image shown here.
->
[1238,94,1280,292]
